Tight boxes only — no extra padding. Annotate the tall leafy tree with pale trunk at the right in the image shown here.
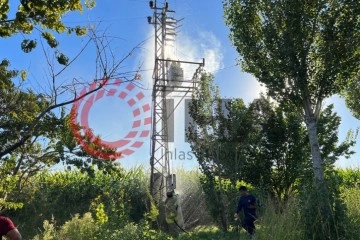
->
[224,0,360,236]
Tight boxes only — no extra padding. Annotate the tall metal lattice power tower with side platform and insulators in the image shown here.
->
[148,1,204,204]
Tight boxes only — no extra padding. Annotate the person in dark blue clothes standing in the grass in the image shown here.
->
[234,186,256,236]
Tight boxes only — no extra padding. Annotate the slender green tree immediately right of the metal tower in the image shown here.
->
[187,74,238,231]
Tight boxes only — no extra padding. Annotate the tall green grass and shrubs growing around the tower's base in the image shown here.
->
[9,168,360,240]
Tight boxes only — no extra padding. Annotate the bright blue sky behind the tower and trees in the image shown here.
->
[0,0,360,168]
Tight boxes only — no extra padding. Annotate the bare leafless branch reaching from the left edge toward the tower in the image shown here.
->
[0,24,146,159]
